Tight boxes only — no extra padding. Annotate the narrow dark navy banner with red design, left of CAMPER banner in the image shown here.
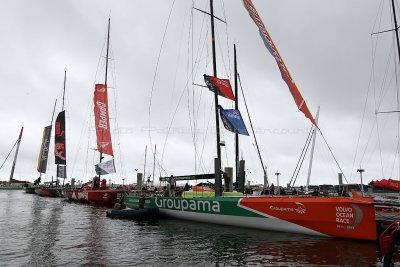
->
[54,110,67,165]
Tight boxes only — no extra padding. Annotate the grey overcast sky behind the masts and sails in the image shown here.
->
[0,0,399,188]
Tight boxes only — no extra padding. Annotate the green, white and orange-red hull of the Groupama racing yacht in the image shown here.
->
[124,195,377,240]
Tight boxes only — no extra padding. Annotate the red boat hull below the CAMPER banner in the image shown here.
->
[64,188,125,207]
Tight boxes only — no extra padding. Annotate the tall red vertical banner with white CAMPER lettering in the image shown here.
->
[93,84,113,156]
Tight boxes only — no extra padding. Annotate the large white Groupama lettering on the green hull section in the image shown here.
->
[155,198,221,213]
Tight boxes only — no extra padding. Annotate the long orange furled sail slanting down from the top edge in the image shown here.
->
[243,0,318,127]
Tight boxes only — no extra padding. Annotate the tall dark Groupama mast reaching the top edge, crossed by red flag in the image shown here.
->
[210,0,221,188]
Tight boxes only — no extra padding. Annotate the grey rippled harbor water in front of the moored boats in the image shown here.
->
[0,190,378,266]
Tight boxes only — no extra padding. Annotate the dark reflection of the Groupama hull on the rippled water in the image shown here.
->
[153,220,377,266]
